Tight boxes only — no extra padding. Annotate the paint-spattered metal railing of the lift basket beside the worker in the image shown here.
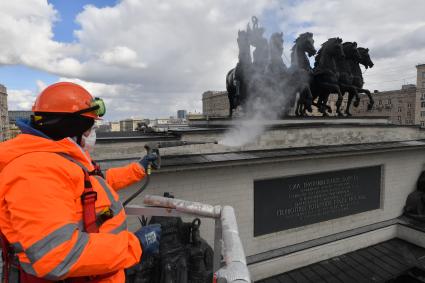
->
[125,195,251,283]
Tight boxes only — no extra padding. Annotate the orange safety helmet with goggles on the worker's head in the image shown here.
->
[32,82,105,119]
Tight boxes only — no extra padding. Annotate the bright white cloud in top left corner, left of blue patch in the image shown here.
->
[0,0,80,75]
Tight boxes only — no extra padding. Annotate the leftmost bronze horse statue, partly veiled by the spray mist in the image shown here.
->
[226,31,252,117]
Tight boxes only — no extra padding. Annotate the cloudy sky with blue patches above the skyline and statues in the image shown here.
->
[0,0,425,120]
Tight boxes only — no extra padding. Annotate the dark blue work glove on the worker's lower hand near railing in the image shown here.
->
[134,224,161,258]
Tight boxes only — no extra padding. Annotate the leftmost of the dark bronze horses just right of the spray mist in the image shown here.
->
[290,32,316,116]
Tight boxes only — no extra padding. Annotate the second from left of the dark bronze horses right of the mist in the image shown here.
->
[310,37,345,116]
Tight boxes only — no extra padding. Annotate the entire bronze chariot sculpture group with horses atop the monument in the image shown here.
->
[226,16,374,117]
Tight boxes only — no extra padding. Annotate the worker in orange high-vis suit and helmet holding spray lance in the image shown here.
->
[0,82,161,283]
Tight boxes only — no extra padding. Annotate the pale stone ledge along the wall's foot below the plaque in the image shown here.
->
[247,216,425,280]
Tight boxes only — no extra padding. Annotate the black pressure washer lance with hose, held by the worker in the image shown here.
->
[123,141,218,207]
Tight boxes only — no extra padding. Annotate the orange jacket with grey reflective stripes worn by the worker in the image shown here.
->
[0,134,145,283]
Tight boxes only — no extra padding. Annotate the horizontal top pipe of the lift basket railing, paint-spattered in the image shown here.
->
[143,195,221,218]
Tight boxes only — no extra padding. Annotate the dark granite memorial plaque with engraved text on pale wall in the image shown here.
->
[254,166,381,237]
